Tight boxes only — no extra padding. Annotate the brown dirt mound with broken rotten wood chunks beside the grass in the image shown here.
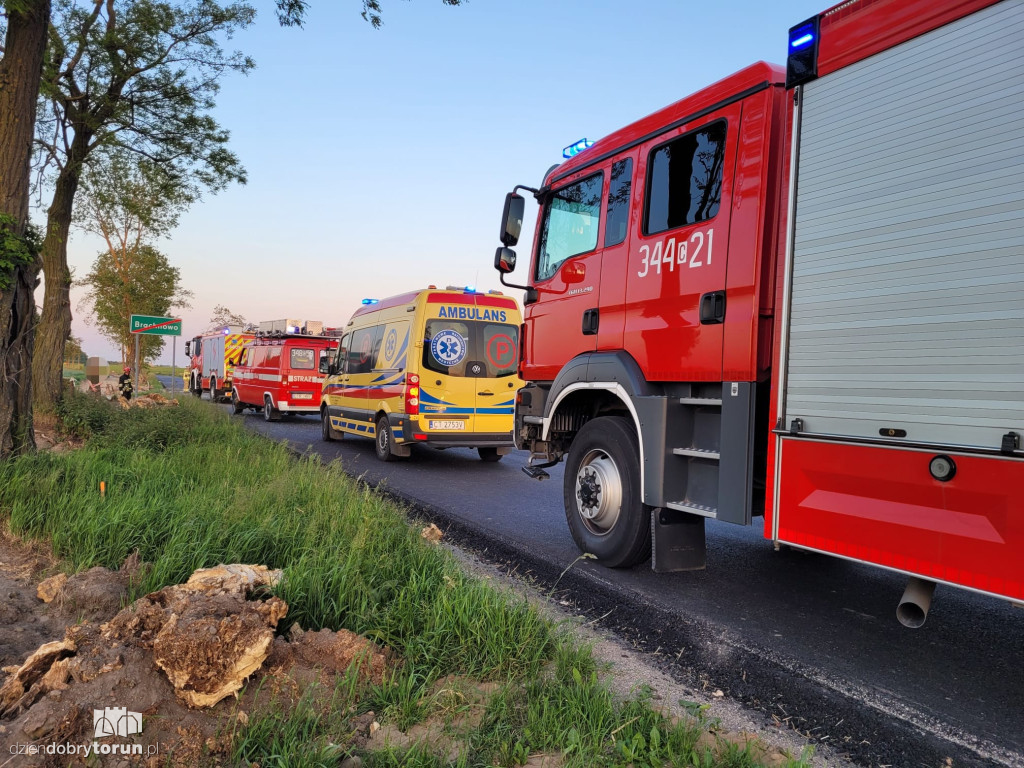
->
[0,563,388,765]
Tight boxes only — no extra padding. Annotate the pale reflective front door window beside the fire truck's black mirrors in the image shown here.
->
[537,173,603,281]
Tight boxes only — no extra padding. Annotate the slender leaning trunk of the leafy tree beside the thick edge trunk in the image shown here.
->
[32,154,83,413]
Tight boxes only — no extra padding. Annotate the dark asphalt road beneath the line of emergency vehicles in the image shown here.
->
[163,385,1024,766]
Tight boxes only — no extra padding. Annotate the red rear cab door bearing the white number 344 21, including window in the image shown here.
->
[624,102,741,381]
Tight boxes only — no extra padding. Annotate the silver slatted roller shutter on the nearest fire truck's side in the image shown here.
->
[783,0,1024,447]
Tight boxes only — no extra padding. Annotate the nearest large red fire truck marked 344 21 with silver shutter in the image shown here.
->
[495,0,1024,626]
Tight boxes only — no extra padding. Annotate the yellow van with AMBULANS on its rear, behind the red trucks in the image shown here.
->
[321,286,523,462]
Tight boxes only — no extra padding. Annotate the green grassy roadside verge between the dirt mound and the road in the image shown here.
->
[0,396,805,768]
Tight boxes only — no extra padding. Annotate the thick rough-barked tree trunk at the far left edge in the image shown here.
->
[0,0,50,459]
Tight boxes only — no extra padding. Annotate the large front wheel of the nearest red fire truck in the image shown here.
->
[562,416,650,568]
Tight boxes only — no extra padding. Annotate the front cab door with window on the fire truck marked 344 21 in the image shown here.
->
[525,171,605,380]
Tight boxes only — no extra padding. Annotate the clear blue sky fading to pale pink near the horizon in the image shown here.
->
[56,0,831,365]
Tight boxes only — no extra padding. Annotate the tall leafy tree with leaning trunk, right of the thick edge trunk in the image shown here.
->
[33,0,255,410]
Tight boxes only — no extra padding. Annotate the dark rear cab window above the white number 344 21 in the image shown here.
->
[644,120,726,234]
